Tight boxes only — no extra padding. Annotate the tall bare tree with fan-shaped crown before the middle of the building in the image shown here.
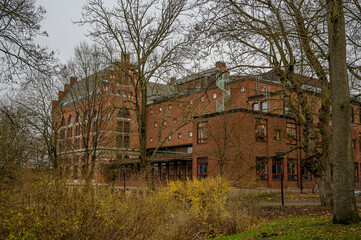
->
[79,0,198,188]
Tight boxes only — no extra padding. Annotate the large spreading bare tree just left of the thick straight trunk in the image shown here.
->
[198,0,332,206]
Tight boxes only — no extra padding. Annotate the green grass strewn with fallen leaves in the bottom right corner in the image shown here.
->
[218,214,361,240]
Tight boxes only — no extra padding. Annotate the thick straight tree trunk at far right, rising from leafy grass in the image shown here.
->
[326,0,360,224]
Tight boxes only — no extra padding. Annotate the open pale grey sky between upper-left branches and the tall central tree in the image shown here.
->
[36,0,87,63]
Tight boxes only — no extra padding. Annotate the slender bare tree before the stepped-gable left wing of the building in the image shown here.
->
[53,43,115,186]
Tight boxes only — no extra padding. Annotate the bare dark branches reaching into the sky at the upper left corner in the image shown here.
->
[0,0,54,82]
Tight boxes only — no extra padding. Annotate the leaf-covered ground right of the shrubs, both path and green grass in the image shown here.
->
[220,194,361,239]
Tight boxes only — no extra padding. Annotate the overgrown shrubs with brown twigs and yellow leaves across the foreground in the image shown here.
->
[0,172,257,239]
